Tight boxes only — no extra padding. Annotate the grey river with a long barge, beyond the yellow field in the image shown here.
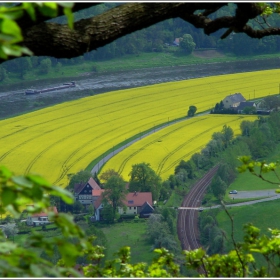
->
[0,58,280,118]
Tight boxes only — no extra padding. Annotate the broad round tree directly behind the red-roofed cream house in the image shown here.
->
[129,162,161,200]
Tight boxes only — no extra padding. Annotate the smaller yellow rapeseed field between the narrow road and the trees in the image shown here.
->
[102,115,256,180]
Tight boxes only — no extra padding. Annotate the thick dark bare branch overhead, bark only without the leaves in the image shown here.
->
[7,2,280,58]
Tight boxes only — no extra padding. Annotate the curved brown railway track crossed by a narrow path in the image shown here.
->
[177,165,219,250]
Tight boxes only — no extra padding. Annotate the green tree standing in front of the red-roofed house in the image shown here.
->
[102,175,127,216]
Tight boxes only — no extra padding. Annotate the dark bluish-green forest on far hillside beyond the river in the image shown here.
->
[0,3,280,81]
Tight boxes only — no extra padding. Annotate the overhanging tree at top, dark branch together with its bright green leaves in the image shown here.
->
[0,2,280,63]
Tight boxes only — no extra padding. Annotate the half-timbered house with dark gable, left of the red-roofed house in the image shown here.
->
[74,178,101,208]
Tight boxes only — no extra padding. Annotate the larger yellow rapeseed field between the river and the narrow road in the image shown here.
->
[0,70,280,187]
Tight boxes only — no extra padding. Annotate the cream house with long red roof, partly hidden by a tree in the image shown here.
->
[92,190,154,221]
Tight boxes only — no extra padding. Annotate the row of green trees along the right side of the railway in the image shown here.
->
[196,112,280,254]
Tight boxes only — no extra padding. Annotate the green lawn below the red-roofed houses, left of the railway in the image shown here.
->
[101,219,156,263]
